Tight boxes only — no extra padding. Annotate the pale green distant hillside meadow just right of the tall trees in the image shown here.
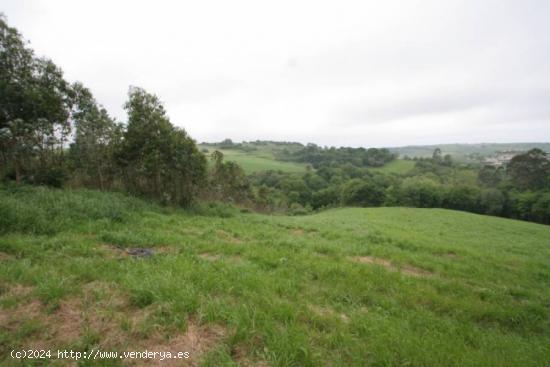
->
[201,146,306,173]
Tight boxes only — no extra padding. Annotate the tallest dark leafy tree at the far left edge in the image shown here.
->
[0,15,72,183]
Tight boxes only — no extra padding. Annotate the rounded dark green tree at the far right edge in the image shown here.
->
[507,148,550,190]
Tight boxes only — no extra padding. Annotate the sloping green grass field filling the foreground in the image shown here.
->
[0,187,550,366]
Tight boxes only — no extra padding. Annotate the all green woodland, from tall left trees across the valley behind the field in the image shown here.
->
[0,17,550,224]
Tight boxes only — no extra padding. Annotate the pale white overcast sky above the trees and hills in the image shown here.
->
[4,0,550,146]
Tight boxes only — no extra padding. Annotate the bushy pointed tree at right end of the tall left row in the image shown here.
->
[117,87,206,205]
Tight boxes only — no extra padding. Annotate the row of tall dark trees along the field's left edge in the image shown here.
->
[0,16,237,206]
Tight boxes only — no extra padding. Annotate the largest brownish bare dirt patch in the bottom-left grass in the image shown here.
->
[0,282,225,366]
